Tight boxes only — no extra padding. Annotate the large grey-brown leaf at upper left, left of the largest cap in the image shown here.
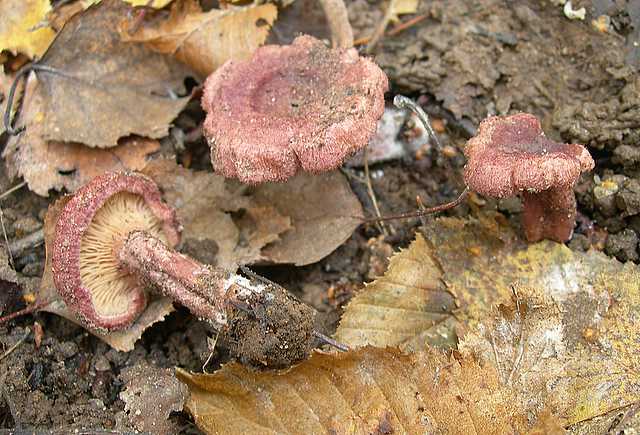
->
[36,0,191,148]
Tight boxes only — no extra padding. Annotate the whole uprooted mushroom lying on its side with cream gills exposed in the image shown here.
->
[51,173,335,367]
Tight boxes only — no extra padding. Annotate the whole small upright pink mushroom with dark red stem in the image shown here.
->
[464,113,594,242]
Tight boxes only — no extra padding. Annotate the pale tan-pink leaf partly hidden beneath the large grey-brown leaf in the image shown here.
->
[3,76,160,196]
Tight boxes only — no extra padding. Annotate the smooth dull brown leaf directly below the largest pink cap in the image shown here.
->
[253,171,363,266]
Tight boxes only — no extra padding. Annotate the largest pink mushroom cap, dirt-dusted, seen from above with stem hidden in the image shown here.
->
[202,36,388,184]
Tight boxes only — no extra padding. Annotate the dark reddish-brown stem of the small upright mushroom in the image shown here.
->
[522,187,576,243]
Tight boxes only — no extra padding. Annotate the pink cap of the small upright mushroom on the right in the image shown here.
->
[464,113,594,198]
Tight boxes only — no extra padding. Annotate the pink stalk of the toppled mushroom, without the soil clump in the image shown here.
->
[117,230,264,327]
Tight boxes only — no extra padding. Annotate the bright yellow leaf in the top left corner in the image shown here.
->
[0,0,55,58]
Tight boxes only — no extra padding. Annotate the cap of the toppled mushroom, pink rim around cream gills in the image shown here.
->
[52,172,180,330]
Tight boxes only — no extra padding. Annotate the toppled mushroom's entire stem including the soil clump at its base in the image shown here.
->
[117,231,316,368]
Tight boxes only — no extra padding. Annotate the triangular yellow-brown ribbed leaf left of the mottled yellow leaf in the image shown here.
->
[335,234,456,350]
